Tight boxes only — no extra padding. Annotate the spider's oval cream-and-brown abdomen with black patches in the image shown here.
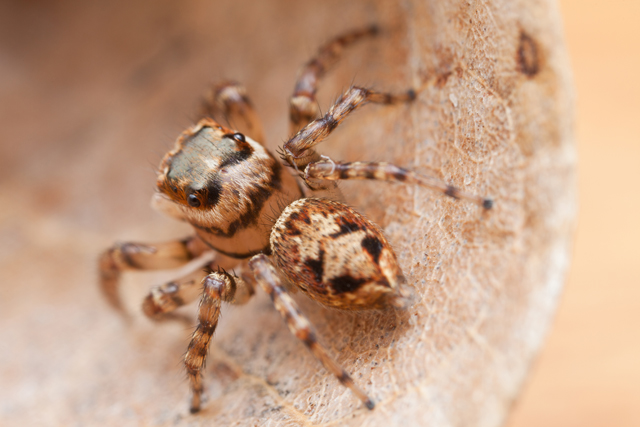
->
[271,199,407,310]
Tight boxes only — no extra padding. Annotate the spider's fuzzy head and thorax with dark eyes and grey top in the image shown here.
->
[157,118,302,258]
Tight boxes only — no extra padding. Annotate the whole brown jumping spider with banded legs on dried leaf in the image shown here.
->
[99,26,493,413]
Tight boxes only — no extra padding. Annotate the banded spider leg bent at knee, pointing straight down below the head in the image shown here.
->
[184,270,253,413]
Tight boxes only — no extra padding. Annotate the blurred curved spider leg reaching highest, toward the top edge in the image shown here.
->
[289,25,378,135]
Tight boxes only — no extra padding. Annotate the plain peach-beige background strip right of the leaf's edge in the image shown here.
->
[508,0,640,427]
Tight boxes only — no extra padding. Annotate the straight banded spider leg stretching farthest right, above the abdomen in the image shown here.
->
[305,161,493,209]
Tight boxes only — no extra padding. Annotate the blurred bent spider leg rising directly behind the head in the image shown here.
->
[202,82,264,143]
